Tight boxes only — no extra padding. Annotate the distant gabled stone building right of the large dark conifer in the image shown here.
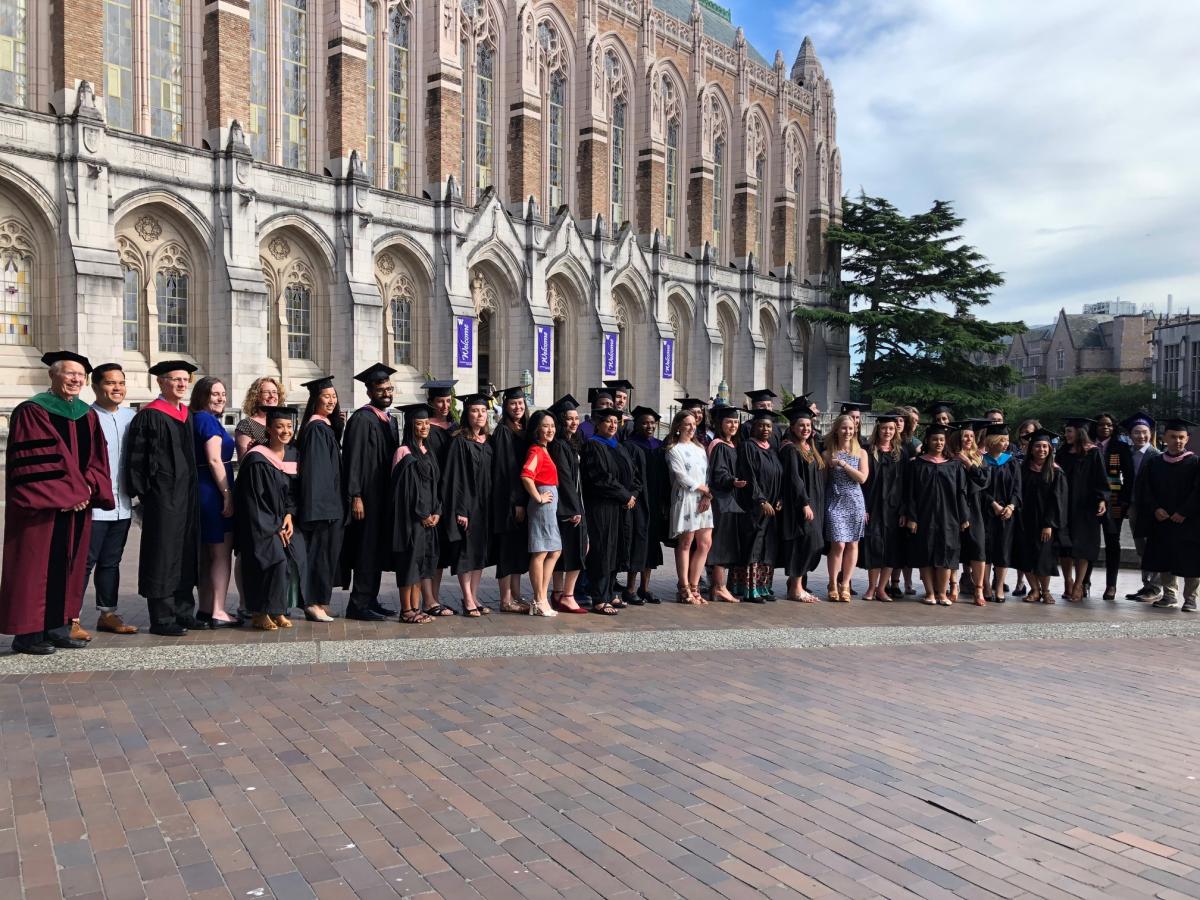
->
[996,306,1157,397]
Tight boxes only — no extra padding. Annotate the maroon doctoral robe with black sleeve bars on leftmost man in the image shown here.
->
[0,401,114,635]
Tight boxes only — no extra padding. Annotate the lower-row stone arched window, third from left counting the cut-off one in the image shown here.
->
[258,224,332,391]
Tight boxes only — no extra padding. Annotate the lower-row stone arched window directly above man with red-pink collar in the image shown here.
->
[114,200,212,371]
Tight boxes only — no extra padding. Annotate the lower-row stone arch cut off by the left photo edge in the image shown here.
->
[0,174,60,368]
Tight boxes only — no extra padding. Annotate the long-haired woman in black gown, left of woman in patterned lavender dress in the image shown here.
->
[779,401,826,604]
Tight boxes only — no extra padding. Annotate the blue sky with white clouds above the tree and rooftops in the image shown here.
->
[725,0,1200,325]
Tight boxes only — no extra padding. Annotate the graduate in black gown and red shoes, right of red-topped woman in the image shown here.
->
[547,394,588,613]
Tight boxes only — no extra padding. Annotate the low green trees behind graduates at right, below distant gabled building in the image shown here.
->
[1001,374,1181,431]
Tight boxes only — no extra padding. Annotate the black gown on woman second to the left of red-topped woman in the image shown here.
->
[441,432,492,575]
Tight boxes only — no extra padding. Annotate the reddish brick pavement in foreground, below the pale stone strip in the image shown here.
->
[0,643,1200,900]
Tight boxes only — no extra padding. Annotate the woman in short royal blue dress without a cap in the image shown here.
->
[188,376,238,628]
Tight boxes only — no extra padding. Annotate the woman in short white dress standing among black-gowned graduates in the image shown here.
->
[664,412,713,606]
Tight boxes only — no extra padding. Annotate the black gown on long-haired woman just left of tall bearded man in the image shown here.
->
[296,419,346,606]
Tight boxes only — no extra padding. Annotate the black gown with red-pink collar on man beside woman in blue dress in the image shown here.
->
[125,408,200,599]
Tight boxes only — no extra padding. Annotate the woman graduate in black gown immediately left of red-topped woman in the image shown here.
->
[488,386,529,613]
